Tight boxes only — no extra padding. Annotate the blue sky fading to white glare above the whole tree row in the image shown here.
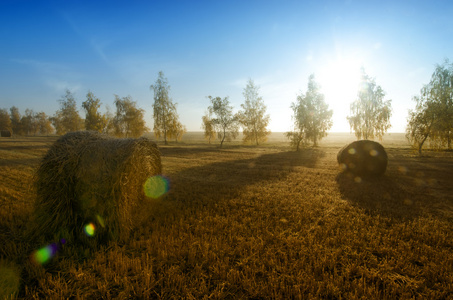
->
[0,0,453,132]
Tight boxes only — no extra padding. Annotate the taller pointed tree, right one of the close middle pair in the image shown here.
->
[238,79,271,145]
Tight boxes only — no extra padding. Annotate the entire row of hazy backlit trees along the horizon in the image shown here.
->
[0,60,453,154]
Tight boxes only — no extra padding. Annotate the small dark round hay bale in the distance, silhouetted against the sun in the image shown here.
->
[337,140,388,176]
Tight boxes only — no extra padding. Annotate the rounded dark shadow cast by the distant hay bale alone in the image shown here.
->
[336,172,421,219]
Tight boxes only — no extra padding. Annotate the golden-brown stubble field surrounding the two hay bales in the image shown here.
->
[0,135,453,299]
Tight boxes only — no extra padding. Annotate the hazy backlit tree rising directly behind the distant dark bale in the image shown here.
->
[347,68,392,140]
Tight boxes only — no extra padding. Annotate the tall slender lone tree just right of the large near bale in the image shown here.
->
[150,71,187,144]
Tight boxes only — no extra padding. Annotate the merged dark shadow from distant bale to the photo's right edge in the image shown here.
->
[336,148,453,220]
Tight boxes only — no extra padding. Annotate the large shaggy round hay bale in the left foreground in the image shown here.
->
[35,131,162,241]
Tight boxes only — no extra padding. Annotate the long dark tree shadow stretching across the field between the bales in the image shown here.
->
[161,148,325,201]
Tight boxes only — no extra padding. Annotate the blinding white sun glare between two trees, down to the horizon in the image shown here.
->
[316,58,362,132]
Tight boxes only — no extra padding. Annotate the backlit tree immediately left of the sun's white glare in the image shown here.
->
[286,74,333,150]
